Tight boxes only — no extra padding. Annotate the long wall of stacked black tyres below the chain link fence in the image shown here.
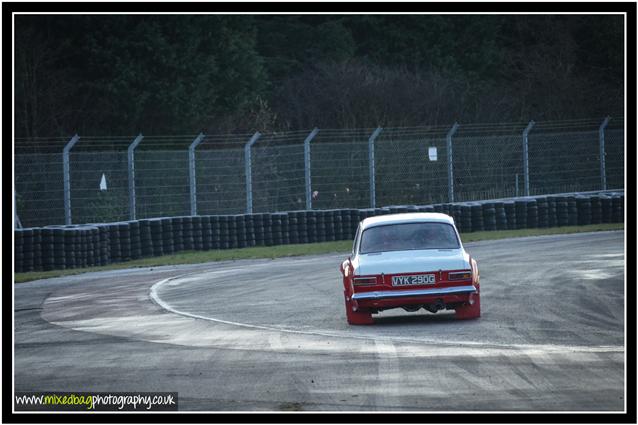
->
[14,192,625,273]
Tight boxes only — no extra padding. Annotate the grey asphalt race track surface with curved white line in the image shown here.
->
[14,232,625,412]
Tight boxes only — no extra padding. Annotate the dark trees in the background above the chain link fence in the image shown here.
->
[15,15,624,137]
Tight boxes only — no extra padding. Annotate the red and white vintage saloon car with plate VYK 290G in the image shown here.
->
[340,213,481,325]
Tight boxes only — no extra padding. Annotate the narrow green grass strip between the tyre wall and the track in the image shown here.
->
[14,223,624,283]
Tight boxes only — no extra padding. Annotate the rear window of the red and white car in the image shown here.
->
[360,222,460,254]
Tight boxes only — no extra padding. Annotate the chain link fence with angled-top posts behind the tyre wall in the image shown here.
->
[14,117,625,227]
